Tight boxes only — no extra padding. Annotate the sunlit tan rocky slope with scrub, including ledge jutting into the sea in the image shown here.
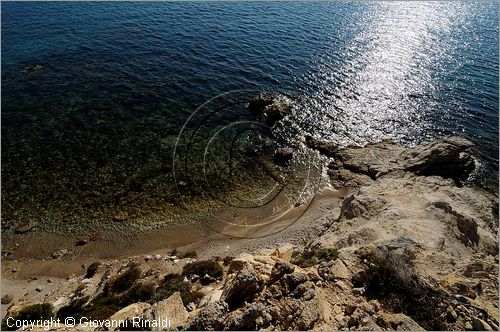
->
[2,108,499,330]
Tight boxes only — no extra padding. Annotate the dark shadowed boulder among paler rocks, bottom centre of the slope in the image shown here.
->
[222,268,262,308]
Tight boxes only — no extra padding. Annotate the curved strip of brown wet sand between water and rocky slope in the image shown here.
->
[2,188,347,279]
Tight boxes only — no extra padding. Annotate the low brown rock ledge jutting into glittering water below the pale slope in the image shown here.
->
[306,136,474,187]
